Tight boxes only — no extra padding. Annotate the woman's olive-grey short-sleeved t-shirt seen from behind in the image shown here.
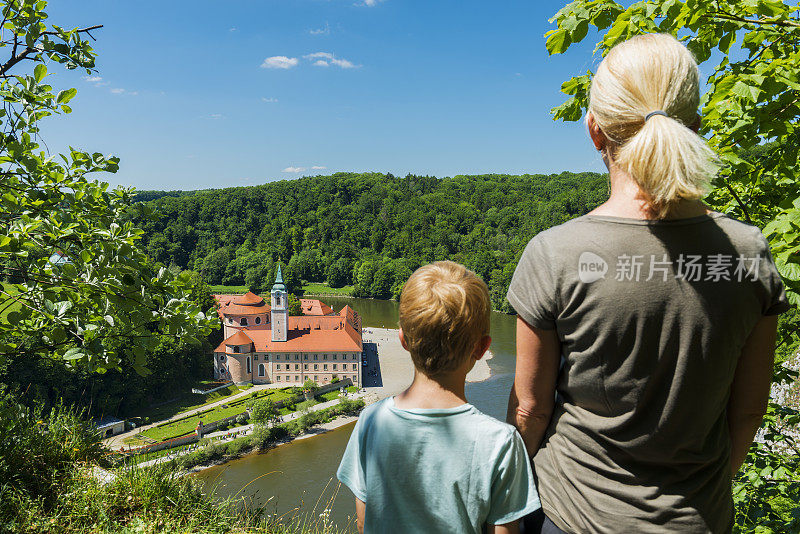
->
[508,213,789,533]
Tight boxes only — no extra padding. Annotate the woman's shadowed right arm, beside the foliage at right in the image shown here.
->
[728,315,778,475]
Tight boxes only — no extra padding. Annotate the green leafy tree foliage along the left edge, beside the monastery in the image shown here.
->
[0,0,216,373]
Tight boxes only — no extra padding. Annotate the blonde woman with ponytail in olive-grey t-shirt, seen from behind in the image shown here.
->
[508,34,789,533]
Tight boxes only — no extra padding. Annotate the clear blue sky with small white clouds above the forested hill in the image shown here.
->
[43,0,605,193]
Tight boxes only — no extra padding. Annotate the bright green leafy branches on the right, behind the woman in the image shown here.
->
[546,0,800,532]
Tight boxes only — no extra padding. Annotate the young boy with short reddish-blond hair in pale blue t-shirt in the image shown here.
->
[337,262,540,534]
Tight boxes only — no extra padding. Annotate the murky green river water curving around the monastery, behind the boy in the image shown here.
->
[195,297,516,530]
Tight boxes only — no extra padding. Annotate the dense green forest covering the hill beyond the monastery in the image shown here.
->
[136,172,607,311]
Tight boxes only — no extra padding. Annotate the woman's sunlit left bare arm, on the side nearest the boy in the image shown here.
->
[507,317,561,456]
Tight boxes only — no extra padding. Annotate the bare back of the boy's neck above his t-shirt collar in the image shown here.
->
[394,369,469,409]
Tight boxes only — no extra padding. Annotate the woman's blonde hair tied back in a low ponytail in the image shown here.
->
[589,34,716,217]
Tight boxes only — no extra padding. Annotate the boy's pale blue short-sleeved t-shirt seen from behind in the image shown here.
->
[336,397,540,534]
